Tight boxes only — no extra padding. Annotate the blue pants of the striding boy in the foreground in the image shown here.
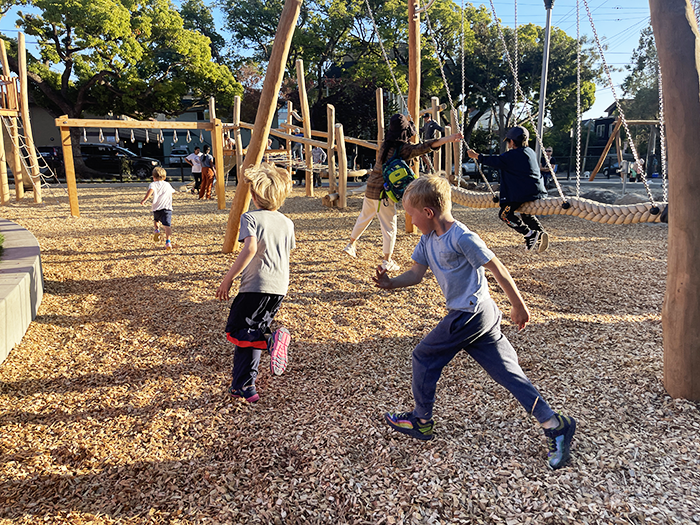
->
[413,299,554,423]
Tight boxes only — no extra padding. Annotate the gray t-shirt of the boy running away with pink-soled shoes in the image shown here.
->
[238,210,296,295]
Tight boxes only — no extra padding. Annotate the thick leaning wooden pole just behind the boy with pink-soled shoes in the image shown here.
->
[222,0,301,253]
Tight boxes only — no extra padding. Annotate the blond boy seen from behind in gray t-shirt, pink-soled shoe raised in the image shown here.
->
[216,163,295,403]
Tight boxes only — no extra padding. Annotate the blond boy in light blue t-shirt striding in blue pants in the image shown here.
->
[374,176,576,469]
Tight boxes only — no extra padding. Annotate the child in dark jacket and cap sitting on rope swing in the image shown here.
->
[467,126,549,252]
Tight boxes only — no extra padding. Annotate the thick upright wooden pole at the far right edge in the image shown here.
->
[649,0,700,401]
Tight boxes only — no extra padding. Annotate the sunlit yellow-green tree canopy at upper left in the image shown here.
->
[6,0,242,118]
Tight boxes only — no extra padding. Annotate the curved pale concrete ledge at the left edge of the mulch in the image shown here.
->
[0,219,44,363]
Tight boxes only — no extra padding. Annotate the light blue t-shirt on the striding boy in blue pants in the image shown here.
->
[412,221,495,312]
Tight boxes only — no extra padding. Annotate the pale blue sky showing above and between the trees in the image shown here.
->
[0,0,650,118]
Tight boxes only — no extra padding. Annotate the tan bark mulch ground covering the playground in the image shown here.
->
[0,186,700,525]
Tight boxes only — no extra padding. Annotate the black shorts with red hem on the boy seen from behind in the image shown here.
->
[226,292,284,350]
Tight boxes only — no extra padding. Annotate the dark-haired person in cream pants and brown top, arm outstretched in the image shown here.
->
[343,113,462,272]
